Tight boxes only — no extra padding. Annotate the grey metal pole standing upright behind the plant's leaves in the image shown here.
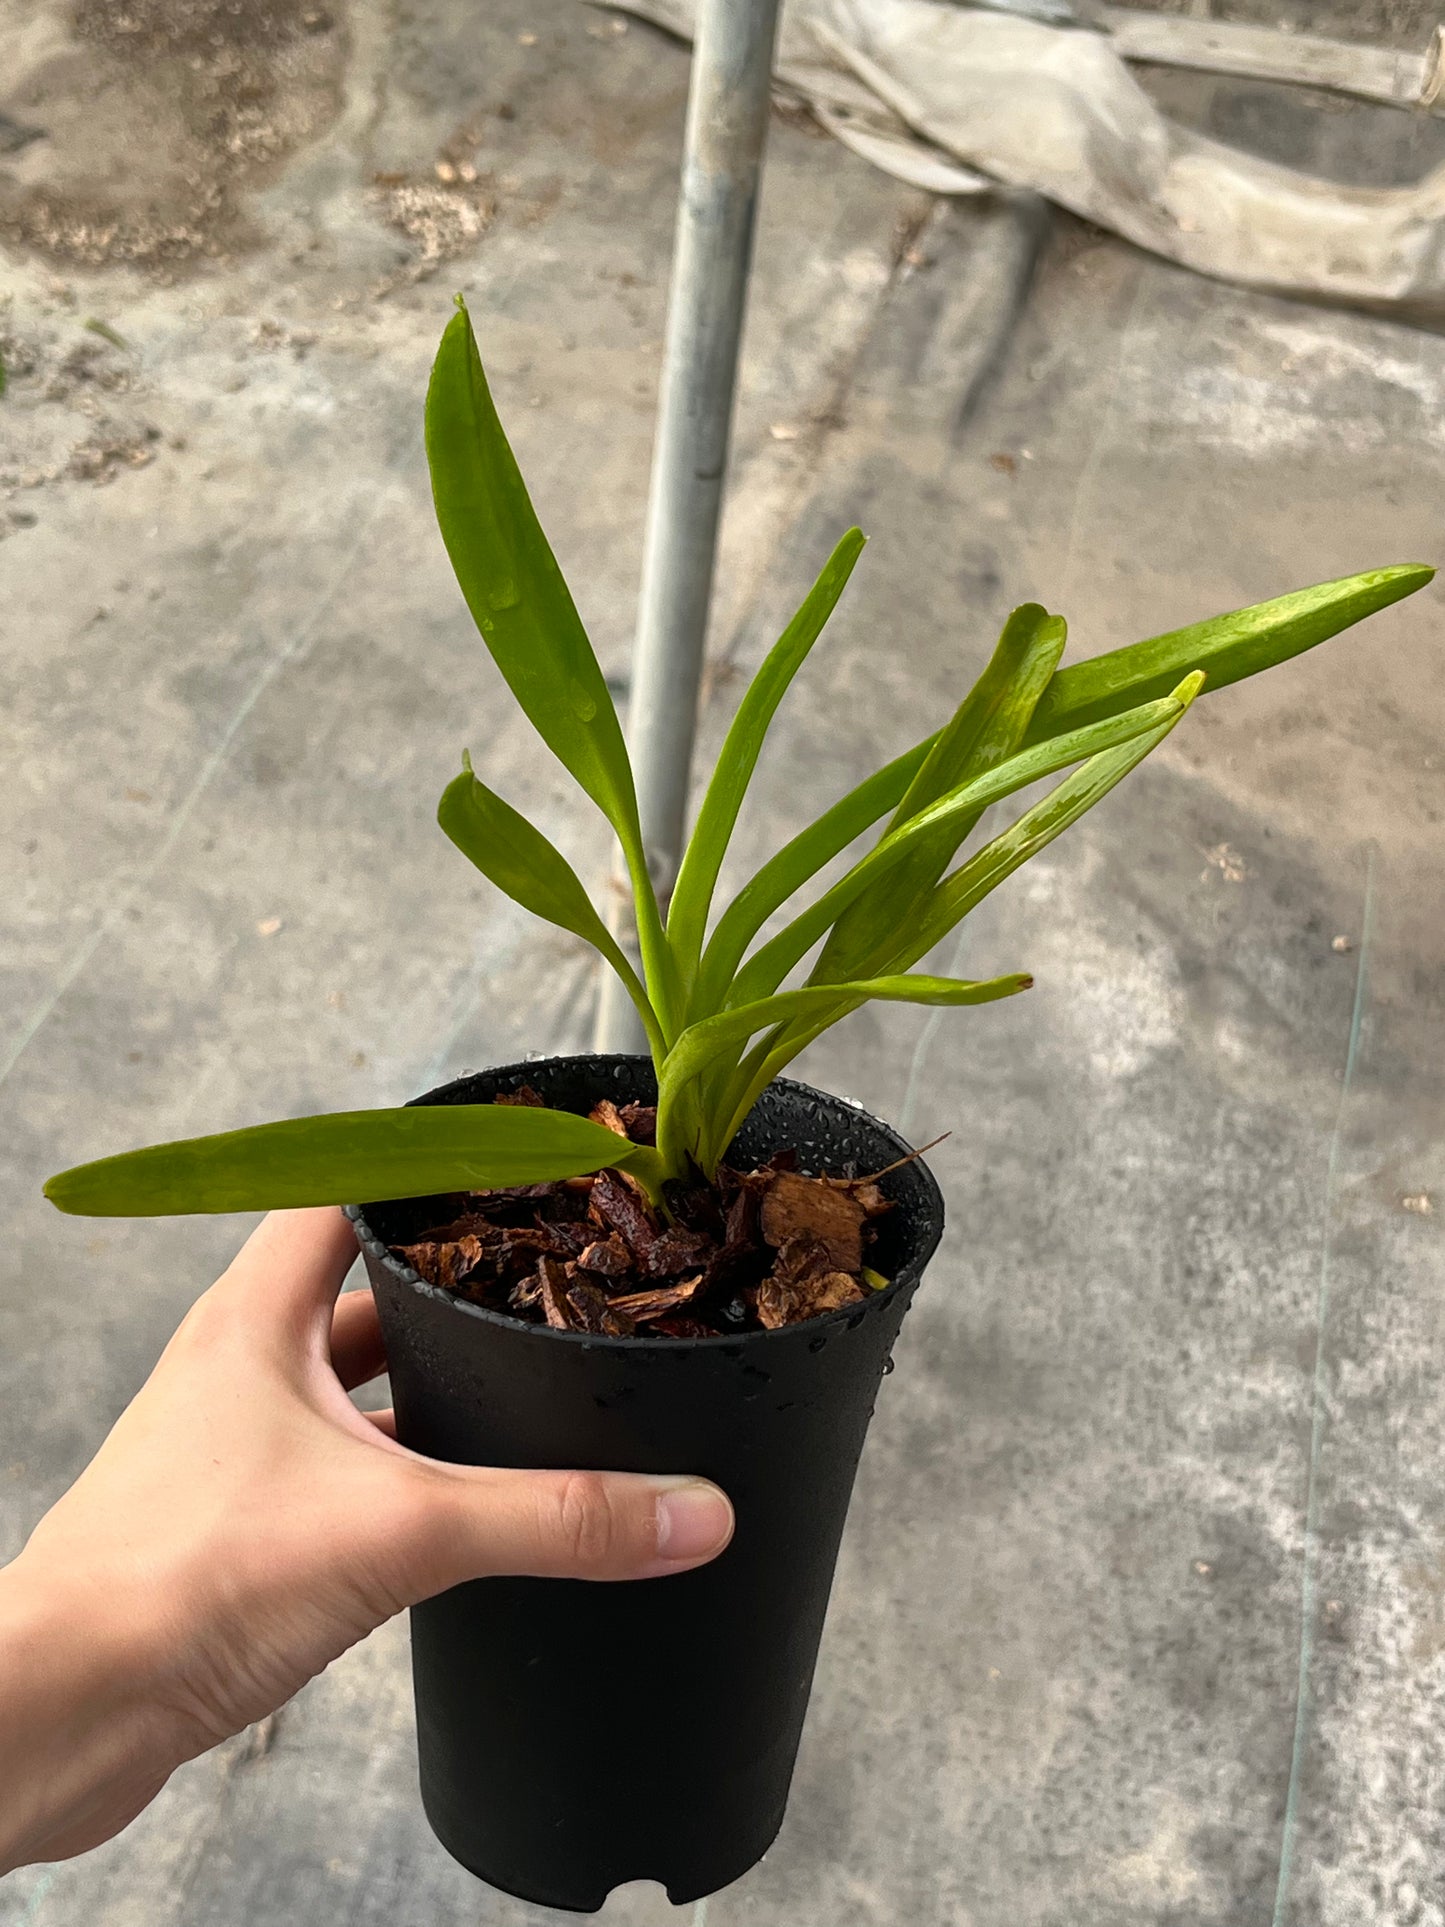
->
[597,0,778,1050]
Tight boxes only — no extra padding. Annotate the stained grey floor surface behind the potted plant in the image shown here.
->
[0,0,1445,1927]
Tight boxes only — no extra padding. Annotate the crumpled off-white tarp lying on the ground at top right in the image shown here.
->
[609,0,1445,326]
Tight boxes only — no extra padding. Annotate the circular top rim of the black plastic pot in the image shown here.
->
[341,1050,944,1359]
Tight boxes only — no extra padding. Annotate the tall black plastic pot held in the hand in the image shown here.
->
[351,1056,942,1912]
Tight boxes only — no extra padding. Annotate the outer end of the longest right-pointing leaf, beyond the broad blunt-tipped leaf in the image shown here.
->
[1027,563,1435,742]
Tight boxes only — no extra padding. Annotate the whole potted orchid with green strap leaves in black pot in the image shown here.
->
[46,303,1432,1908]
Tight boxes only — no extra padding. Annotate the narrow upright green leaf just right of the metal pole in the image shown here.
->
[667,528,863,987]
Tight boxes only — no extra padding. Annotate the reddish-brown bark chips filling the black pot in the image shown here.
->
[391,1087,890,1337]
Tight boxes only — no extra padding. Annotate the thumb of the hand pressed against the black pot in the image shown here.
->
[396,1465,734,1599]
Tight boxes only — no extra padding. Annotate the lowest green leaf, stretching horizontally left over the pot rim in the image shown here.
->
[44,1104,659,1218]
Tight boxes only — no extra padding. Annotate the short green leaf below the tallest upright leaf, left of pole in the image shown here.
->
[437,753,667,1064]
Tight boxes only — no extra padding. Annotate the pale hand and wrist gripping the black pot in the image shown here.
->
[0,1208,732,1873]
